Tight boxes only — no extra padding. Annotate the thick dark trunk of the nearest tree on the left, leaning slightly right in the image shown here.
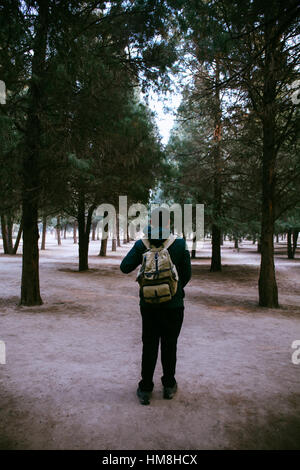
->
[21,0,49,305]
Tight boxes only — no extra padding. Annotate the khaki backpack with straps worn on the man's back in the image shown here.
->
[136,235,178,304]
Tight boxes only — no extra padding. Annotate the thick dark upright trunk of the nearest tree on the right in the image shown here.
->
[258,11,278,308]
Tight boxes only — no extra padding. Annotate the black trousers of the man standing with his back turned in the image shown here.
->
[139,305,184,391]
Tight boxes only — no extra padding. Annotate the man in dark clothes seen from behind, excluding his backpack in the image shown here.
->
[120,208,191,405]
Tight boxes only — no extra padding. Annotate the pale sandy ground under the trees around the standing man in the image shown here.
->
[0,236,300,450]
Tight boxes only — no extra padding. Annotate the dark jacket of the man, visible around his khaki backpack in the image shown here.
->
[120,238,191,308]
